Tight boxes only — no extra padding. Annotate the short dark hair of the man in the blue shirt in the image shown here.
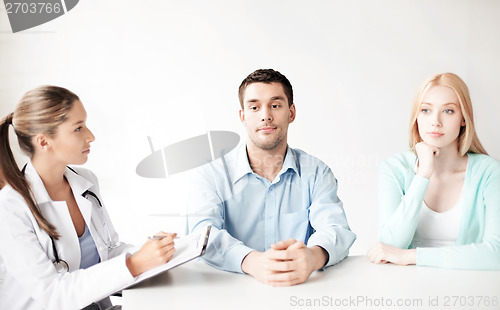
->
[238,69,293,109]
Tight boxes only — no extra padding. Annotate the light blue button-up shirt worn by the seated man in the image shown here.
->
[189,144,356,272]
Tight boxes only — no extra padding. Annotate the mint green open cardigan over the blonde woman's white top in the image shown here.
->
[378,152,500,270]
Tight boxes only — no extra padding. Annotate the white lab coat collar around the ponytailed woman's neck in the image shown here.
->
[24,161,93,204]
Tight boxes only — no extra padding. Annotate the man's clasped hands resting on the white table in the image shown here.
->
[241,239,328,286]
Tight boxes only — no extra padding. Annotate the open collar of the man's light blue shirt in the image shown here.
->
[231,143,300,184]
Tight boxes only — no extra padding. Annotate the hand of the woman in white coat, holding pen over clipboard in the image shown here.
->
[127,232,177,277]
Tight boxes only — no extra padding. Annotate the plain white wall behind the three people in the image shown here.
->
[0,0,500,254]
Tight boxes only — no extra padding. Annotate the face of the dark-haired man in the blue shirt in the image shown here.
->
[240,83,295,150]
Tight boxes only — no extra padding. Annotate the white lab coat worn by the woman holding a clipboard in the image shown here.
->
[0,162,134,310]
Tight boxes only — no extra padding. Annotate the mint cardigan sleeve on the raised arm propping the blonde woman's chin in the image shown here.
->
[378,154,429,249]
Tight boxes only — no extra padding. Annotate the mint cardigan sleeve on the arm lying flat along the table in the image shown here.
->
[417,159,500,270]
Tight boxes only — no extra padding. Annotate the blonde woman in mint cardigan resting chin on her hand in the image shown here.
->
[368,73,500,269]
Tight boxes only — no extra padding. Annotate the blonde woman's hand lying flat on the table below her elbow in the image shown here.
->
[367,242,417,265]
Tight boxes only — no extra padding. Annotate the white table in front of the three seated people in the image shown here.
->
[123,256,500,310]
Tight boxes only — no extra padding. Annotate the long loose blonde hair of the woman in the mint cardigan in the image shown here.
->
[409,73,488,156]
